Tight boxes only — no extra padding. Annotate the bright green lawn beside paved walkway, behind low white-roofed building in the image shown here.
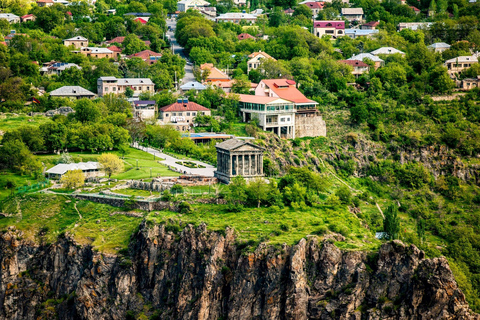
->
[38,148,180,180]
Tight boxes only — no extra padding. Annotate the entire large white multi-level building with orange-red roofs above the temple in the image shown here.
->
[239,79,327,139]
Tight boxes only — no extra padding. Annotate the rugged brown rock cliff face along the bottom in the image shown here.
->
[0,224,480,320]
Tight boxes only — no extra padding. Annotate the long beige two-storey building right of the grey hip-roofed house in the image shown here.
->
[97,77,155,97]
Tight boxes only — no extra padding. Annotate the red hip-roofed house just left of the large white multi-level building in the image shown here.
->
[158,98,212,131]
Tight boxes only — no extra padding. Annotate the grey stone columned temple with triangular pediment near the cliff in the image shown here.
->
[214,139,265,184]
